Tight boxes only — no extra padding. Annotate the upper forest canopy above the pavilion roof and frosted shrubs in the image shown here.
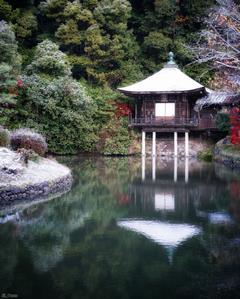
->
[0,0,214,86]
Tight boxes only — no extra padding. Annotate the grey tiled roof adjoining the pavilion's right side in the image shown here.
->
[194,89,240,111]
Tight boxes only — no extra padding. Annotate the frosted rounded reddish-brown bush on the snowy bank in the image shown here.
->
[11,129,47,156]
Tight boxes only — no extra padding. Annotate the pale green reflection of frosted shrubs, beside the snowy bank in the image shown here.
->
[15,159,138,271]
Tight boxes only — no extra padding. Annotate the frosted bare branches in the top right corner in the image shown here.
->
[186,0,240,86]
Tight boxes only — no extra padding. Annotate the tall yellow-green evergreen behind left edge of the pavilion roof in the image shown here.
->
[40,0,140,86]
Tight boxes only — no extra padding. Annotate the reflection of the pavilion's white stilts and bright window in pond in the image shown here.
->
[136,156,194,216]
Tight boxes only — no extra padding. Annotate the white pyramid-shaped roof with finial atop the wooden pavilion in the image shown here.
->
[118,52,205,95]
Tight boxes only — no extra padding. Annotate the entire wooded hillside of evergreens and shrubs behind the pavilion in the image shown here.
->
[0,0,221,154]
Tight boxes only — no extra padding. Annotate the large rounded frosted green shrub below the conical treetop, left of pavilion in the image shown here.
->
[17,76,97,154]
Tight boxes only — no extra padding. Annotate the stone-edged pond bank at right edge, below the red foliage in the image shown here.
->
[214,139,240,169]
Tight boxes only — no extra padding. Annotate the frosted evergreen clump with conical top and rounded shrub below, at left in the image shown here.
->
[3,40,96,154]
